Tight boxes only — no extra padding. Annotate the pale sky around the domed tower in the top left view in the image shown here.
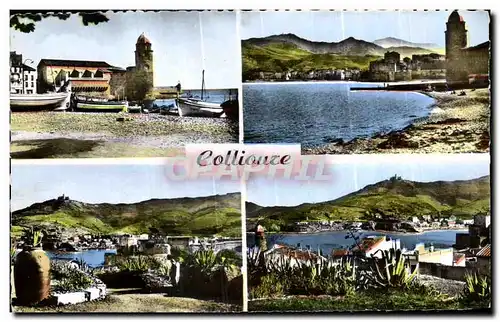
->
[10,11,241,89]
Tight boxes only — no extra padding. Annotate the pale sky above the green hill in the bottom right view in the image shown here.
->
[246,156,490,206]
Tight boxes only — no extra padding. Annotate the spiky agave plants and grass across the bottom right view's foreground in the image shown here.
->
[248,249,491,312]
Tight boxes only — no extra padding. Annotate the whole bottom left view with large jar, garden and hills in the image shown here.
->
[10,160,243,313]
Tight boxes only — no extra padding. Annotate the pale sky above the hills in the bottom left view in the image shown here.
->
[11,164,240,211]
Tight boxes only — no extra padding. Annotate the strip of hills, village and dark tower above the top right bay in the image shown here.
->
[242,11,490,85]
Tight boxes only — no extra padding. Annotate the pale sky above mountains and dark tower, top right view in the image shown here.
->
[240,11,489,48]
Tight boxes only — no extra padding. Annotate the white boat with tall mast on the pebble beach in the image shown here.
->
[176,71,224,117]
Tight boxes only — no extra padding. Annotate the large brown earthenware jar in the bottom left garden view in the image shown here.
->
[14,247,50,305]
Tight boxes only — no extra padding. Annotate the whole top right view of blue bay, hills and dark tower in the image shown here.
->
[240,10,491,154]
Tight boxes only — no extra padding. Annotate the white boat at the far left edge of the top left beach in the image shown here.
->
[10,93,69,110]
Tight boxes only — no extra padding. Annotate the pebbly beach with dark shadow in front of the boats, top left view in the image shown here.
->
[11,112,238,158]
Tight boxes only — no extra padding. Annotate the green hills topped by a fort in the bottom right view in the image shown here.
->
[246,176,490,230]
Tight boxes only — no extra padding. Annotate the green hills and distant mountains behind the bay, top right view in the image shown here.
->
[242,34,437,79]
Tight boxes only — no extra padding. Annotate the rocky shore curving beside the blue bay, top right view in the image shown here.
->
[302,88,491,154]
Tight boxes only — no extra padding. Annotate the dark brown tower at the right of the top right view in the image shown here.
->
[445,10,468,82]
